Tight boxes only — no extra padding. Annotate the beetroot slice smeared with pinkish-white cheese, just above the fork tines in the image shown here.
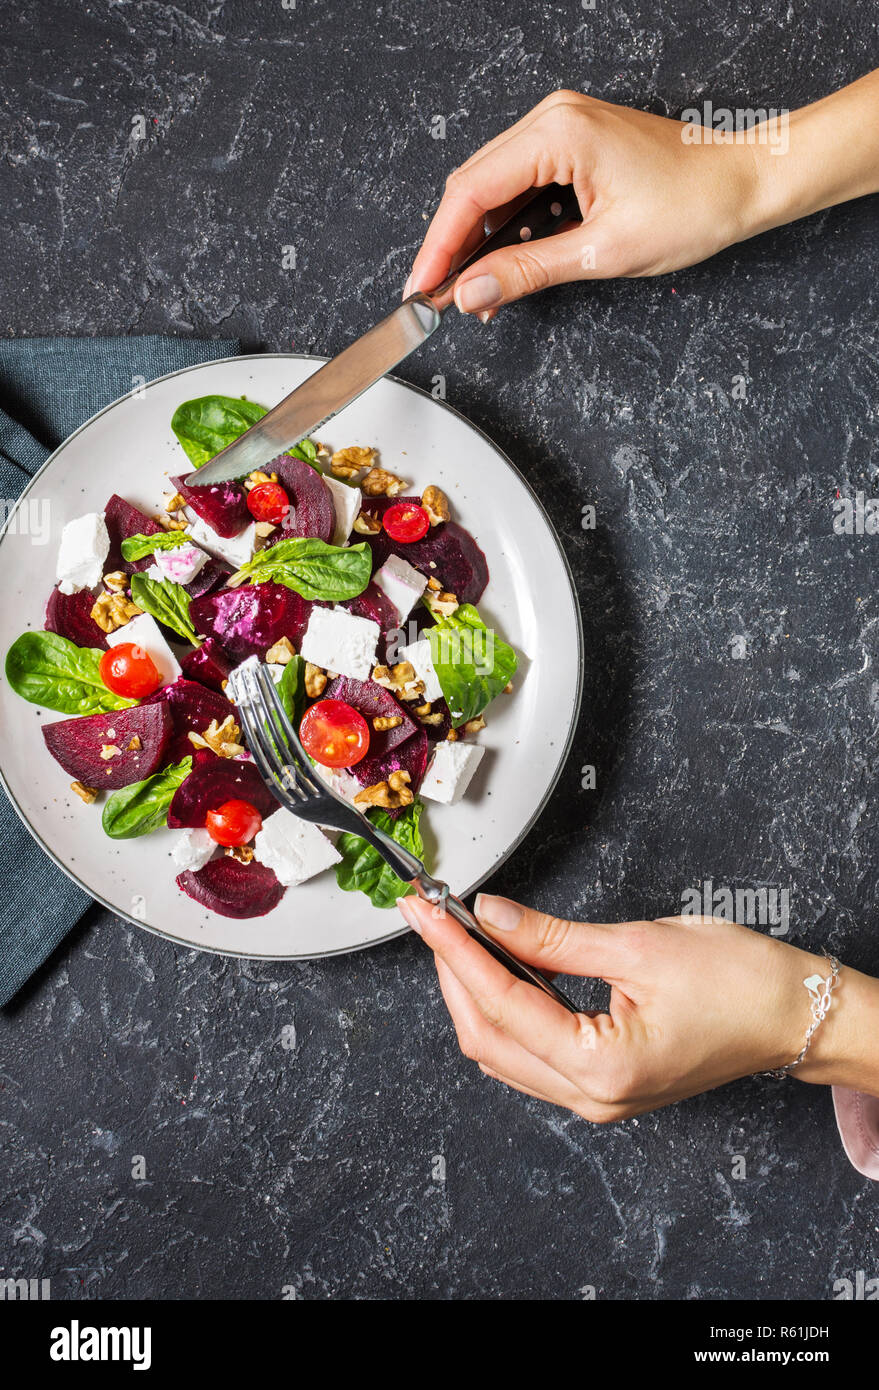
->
[189,581,312,664]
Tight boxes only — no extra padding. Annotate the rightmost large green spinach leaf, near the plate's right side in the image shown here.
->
[426,603,519,728]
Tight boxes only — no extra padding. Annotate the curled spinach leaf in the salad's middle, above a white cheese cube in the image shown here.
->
[229,537,373,603]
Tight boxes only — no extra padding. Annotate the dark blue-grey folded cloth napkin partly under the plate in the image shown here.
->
[0,336,241,1006]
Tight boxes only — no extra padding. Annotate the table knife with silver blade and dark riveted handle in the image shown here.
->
[186,183,581,487]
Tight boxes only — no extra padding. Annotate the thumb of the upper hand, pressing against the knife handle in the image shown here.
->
[455,228,597,314]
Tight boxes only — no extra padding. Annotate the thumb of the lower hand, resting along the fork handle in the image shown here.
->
[474,892,623,980]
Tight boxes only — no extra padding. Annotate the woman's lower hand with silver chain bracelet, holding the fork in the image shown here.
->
[398,894,879,1123]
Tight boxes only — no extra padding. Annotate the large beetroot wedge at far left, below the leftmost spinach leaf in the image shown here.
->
[42,705,171,791]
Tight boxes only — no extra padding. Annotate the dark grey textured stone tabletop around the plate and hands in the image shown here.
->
[0,0,879,1298]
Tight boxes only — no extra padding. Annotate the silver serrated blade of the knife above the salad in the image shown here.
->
[186,295,442,488]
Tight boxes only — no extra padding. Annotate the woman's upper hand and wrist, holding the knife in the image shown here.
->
[403,74,879,317]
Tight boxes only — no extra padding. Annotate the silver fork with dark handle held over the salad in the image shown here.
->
[227,656,577,1013]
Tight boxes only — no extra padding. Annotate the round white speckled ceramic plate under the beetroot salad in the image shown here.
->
[0,353,583,959]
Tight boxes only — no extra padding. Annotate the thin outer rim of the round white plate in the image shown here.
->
[0,352,586,962]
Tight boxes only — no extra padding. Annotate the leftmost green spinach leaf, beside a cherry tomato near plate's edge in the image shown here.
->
[6,632,138,714]
